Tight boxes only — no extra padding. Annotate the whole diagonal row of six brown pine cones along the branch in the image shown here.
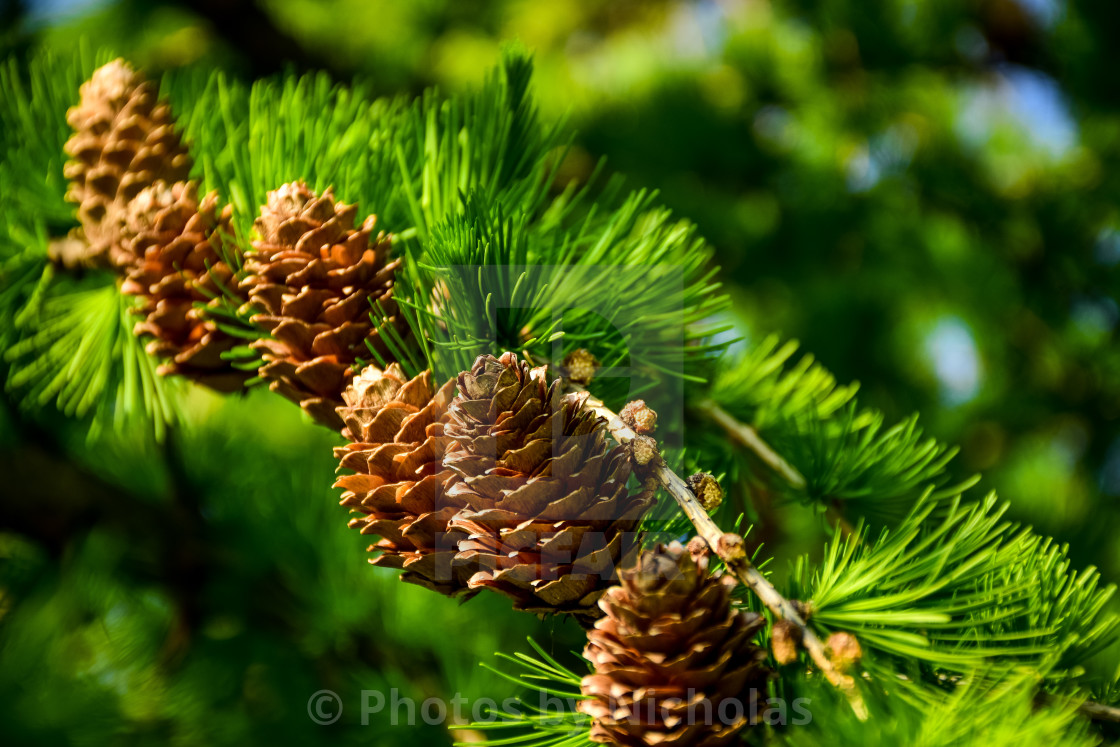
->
[55,60,769,747]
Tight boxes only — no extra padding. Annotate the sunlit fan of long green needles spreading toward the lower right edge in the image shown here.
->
[790,495,1117,681]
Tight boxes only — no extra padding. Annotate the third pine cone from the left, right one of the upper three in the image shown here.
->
[242,181,403,429]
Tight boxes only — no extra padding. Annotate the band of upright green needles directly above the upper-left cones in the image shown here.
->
[165,49,559,245]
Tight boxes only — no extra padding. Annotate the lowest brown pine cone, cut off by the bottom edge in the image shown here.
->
[579,542,769,747]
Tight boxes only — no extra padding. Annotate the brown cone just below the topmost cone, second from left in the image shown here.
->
[121,181,250,392]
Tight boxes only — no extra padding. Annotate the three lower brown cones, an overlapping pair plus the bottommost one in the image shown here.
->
[336,353,769,747]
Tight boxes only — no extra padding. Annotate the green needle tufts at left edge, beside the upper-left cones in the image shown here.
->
[0,45,183,439]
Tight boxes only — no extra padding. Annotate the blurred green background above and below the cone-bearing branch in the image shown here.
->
[0,0,1120,745]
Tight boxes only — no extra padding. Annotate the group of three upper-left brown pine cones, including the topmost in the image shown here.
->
[54,59,403,428]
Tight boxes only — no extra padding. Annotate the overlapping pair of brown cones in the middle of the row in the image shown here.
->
[336,353,652,619]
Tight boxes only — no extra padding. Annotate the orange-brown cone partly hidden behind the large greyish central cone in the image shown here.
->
[335,363,467,595]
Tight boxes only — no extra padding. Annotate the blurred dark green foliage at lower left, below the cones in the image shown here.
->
[0,391,555,747]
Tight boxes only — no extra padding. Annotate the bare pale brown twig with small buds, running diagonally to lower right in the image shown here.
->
[569,384,868,720]
